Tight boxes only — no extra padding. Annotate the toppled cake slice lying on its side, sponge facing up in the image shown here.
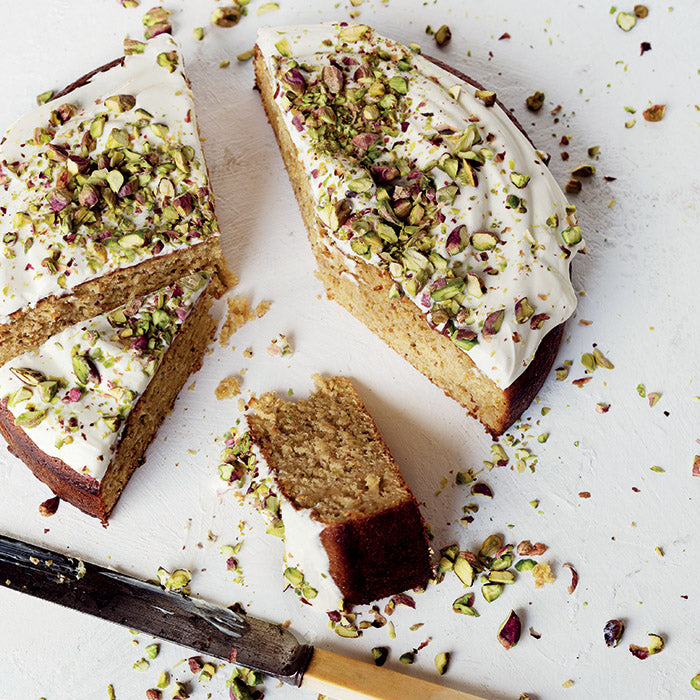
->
[222,377,431,611]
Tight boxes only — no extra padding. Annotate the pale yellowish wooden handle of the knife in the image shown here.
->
[301,649,484,700]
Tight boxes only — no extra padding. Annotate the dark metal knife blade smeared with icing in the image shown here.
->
[0,534,313,686]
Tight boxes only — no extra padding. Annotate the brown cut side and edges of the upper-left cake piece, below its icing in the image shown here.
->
[0,47,235,365]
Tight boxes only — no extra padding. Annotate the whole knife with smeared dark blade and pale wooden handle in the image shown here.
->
[0,535,484,700]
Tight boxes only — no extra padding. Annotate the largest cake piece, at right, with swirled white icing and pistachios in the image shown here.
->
[255,23,583,436]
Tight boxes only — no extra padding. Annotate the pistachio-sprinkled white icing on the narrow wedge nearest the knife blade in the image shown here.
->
[0,272,210,481]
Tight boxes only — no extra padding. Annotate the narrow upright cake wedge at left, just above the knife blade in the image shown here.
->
[0,272,216,523]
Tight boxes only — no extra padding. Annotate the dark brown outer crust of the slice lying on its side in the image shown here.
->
[249,377,432,604]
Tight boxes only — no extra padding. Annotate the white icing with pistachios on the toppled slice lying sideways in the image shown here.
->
[219,416,343,611]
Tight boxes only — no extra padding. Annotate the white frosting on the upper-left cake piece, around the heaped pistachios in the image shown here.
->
[0,35,217,323]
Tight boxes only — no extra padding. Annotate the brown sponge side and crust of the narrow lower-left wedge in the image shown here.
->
[0,285,216,525]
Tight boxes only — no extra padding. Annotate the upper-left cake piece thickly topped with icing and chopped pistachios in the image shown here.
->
[0,35,230,364]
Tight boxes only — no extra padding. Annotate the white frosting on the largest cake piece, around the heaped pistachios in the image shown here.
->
[258,24,583,388]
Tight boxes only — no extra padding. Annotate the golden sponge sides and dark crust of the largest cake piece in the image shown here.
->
[254,46,564,437]
